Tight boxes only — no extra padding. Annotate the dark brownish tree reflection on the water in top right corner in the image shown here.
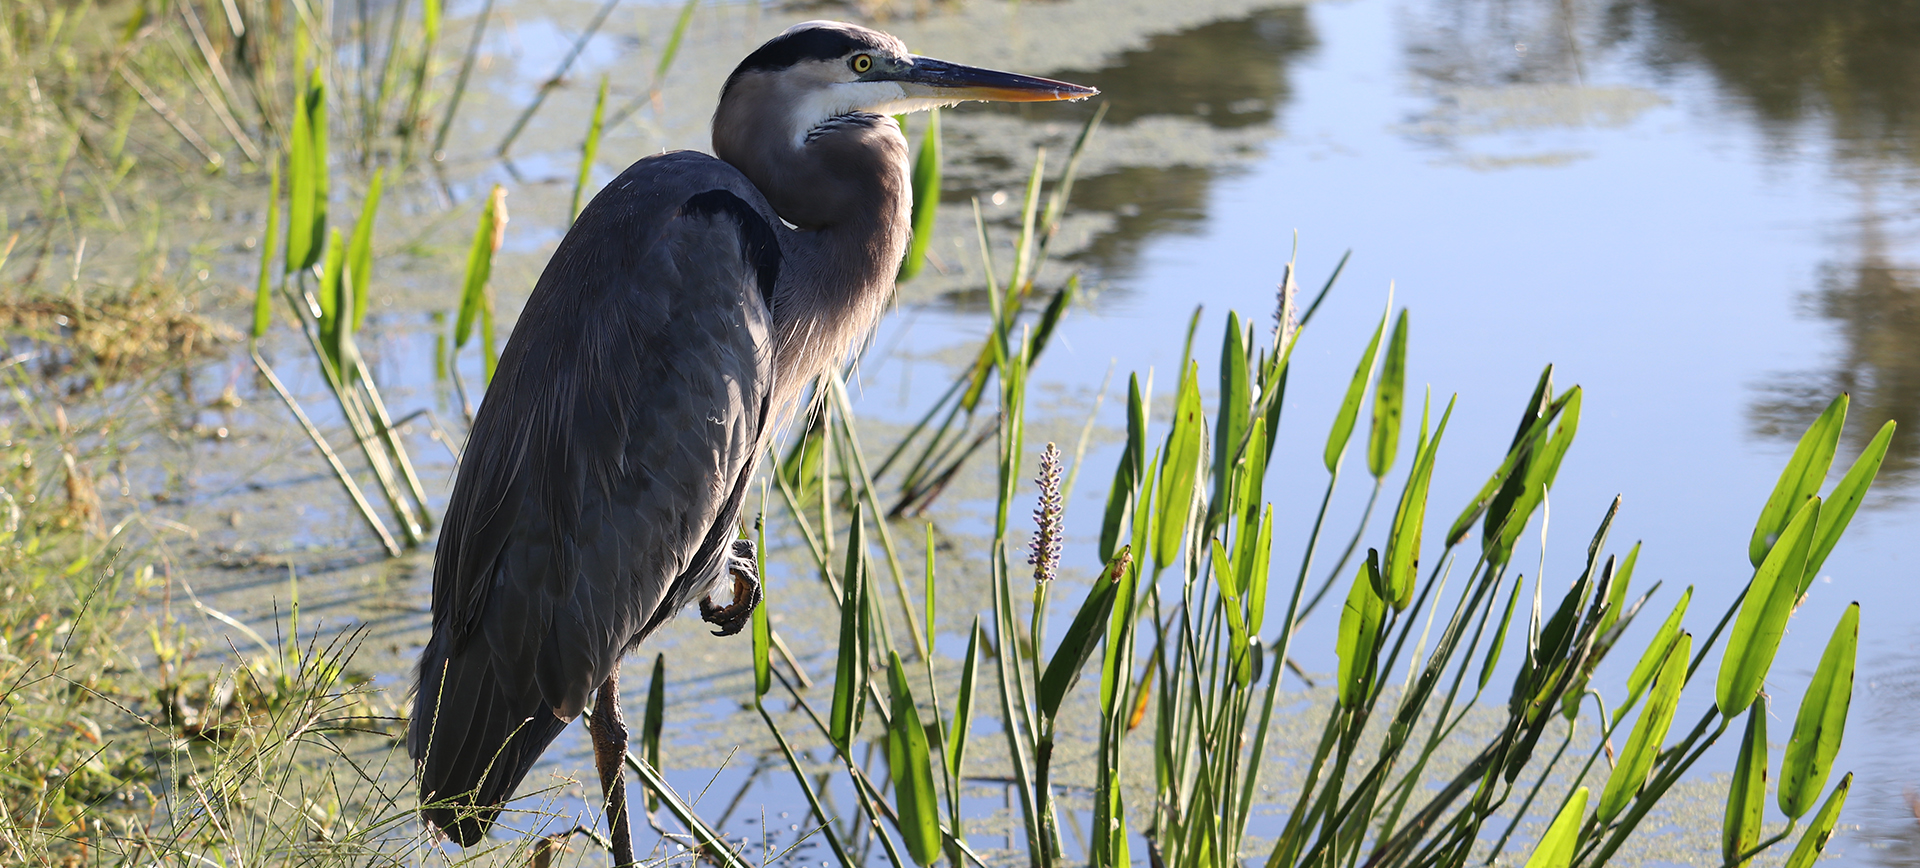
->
[1611,0,1920,484]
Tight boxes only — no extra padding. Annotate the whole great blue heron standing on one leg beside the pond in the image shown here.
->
[407,21,1094,864]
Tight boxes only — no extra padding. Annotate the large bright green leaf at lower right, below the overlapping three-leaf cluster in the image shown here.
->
[1780,603,1860,820]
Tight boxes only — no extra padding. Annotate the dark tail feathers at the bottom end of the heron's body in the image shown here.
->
[407,633,566,847]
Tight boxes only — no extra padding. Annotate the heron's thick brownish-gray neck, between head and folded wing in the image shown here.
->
[714,108,912,407]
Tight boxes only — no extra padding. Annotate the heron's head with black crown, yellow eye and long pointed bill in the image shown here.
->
[714,21,1098,146]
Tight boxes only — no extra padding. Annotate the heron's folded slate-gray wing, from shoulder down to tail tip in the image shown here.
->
[409,154,780,837]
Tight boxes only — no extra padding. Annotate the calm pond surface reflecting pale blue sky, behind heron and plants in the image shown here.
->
[145,0,1920,864]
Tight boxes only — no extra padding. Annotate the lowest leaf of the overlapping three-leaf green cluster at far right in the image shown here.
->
[1715,497,1820,716]
